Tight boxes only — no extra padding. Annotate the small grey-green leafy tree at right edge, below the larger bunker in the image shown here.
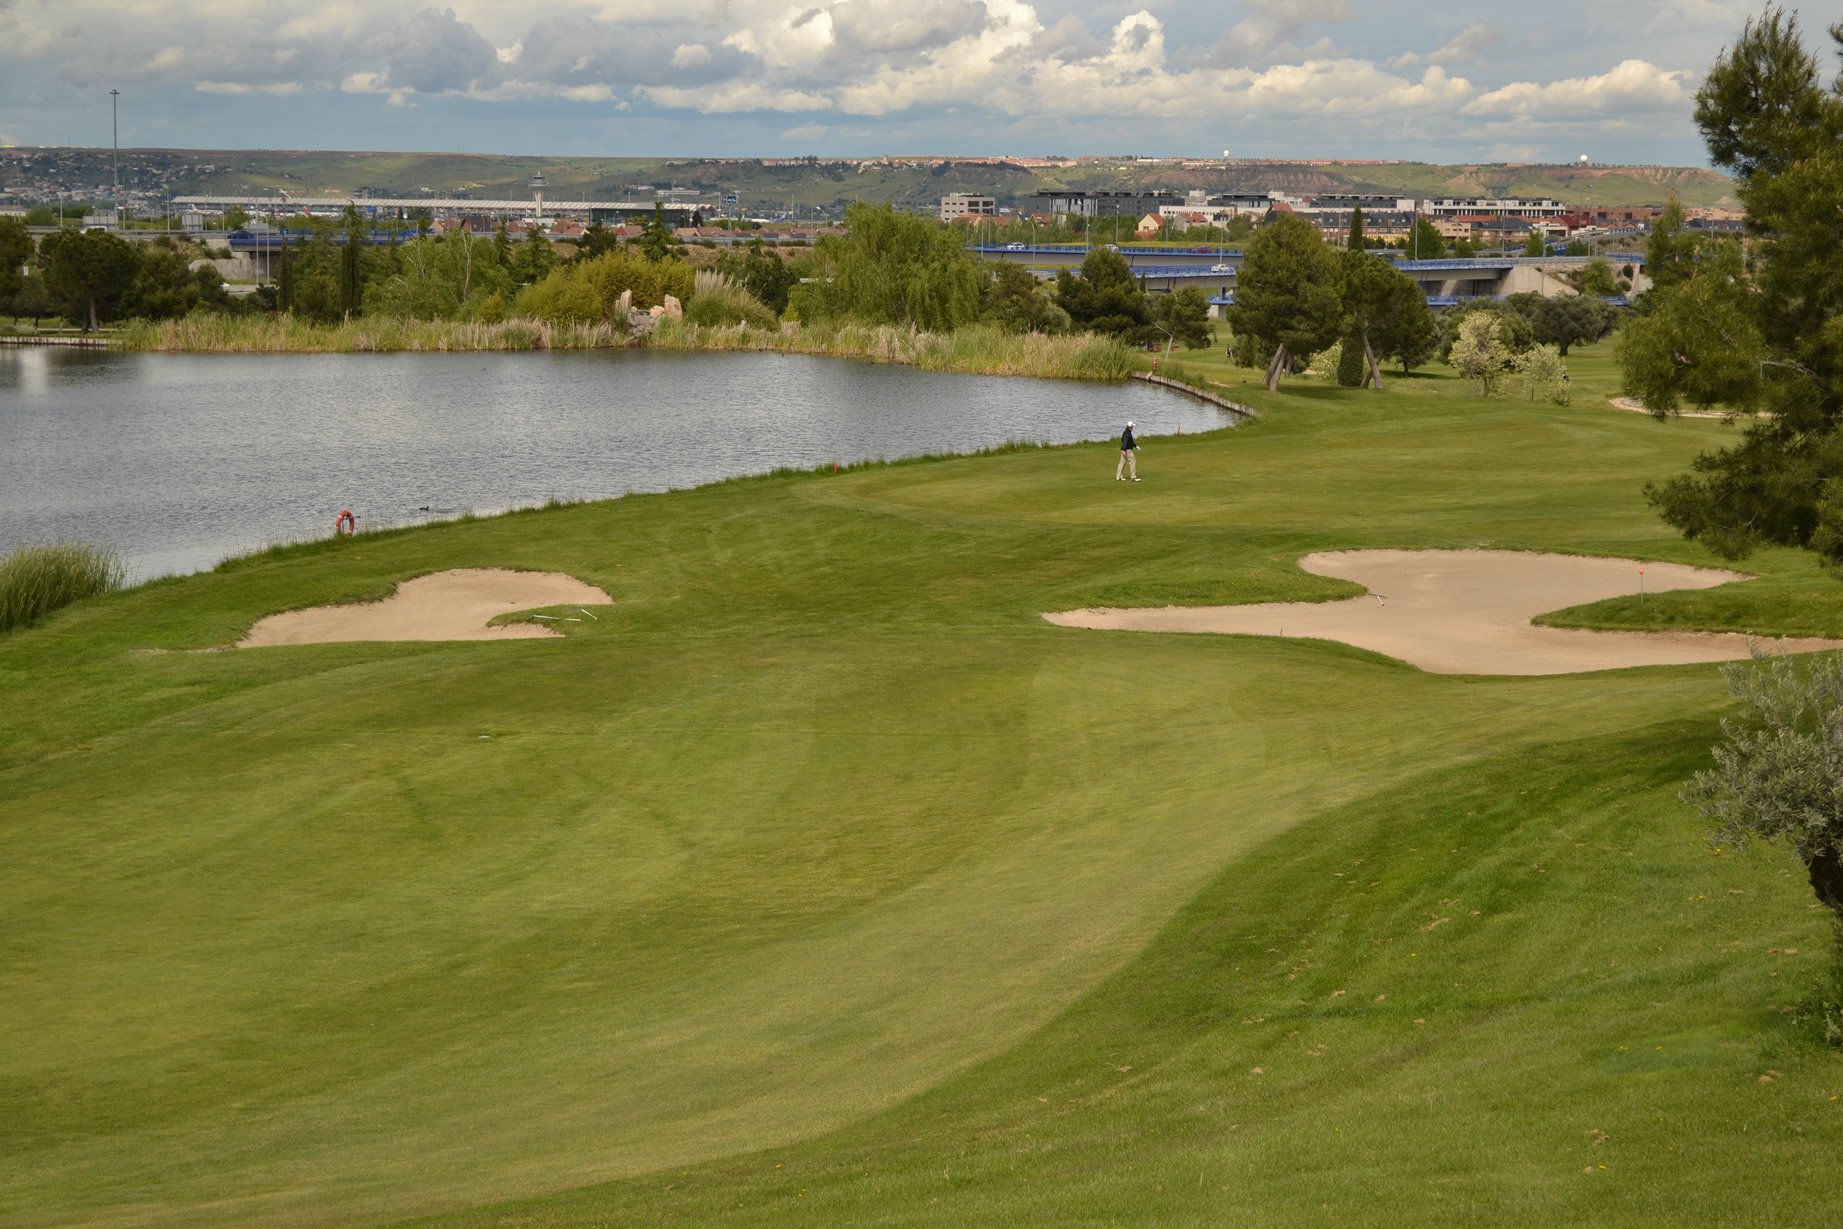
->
[1683,652,1843,925]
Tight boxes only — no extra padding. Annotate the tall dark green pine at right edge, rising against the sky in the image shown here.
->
[1620,6,1843,564]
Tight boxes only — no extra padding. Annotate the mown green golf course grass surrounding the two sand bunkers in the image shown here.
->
[0,340,1843,1225]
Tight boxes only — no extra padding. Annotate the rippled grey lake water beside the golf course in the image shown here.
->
[0,348,1229,579]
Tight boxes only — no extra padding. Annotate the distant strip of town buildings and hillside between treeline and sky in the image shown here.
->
[0,147,1742,245]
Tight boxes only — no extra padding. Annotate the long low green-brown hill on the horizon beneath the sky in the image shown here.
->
[0,147,1734,214]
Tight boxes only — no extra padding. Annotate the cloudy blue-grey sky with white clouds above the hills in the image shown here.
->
[0,0,1784,166]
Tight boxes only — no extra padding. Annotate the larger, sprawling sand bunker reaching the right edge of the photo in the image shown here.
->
[1043,551,1843,674]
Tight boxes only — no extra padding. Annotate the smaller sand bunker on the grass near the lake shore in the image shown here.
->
[238,568,610,649]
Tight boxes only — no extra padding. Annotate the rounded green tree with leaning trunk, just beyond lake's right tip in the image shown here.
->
[1229,214,1344,392]
